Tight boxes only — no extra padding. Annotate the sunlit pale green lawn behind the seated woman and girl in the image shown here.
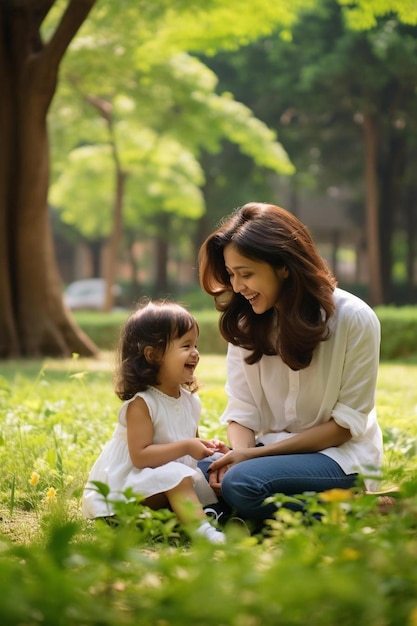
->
[0,353,417,538]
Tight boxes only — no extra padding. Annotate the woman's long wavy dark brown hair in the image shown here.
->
[199,202,336,370]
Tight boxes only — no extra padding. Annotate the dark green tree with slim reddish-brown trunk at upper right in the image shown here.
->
[202,0,417,304]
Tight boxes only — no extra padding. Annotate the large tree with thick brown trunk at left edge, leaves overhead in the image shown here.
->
[0,0,308,358]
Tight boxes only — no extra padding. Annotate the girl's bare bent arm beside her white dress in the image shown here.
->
[126,397,213,469]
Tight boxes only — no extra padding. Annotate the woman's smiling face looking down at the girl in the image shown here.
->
[223,243,288,314]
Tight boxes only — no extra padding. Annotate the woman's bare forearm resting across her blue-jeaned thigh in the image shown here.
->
[209,419,352,473]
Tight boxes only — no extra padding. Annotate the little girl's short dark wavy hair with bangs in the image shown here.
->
[115,300,198,400]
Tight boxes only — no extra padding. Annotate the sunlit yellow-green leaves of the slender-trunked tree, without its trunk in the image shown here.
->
[50,41,292,238]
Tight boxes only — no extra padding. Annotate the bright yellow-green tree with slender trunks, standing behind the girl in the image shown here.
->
[50,51,292,295]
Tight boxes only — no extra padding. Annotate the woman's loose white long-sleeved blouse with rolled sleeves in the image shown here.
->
[221,289,382,489]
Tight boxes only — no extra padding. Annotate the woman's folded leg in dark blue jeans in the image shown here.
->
[222,452,357,520]
